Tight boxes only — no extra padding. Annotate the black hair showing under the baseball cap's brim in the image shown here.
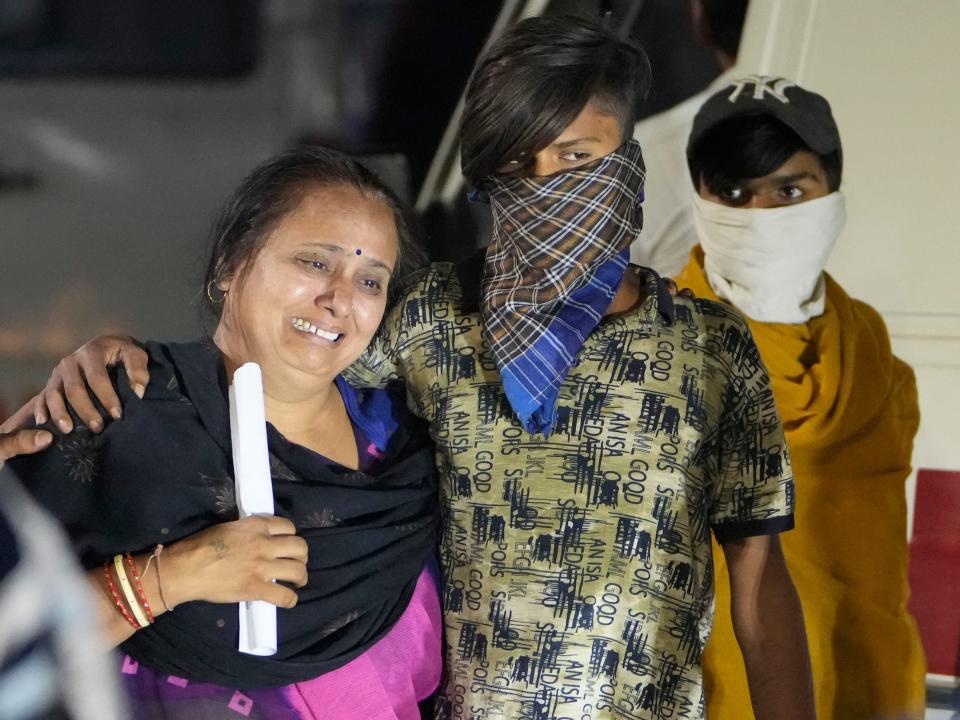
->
[687,115,841,194]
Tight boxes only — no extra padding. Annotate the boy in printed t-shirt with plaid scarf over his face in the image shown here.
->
[3,17,812,719]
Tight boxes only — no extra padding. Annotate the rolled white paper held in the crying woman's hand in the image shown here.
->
[230,363,277,655]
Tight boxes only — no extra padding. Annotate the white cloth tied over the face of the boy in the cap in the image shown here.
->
[693,192,847,323]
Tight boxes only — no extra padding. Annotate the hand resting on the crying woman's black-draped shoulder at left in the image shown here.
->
[32,335,150,433]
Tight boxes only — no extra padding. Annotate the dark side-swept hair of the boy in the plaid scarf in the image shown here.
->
[460,15,650,185]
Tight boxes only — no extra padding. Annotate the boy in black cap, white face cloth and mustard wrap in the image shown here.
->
[676,76,925,720]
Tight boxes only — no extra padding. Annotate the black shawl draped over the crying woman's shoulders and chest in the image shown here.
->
[12,340,437,687]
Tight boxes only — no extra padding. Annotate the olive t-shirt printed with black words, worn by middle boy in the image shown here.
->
[346,261,793,720]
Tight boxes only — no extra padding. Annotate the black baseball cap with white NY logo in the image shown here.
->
[687,75,842,159]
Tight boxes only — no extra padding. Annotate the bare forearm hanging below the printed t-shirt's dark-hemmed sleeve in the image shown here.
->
[724,539,816,720]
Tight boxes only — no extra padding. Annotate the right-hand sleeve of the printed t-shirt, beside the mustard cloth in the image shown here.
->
[710,318,794,542]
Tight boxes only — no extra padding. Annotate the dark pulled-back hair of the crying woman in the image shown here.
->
[201,147,423,317]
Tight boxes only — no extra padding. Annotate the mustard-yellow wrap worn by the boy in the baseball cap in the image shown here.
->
[677,246,925,720]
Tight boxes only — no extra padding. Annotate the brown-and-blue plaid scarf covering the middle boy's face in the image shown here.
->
[480,140,644,435]
